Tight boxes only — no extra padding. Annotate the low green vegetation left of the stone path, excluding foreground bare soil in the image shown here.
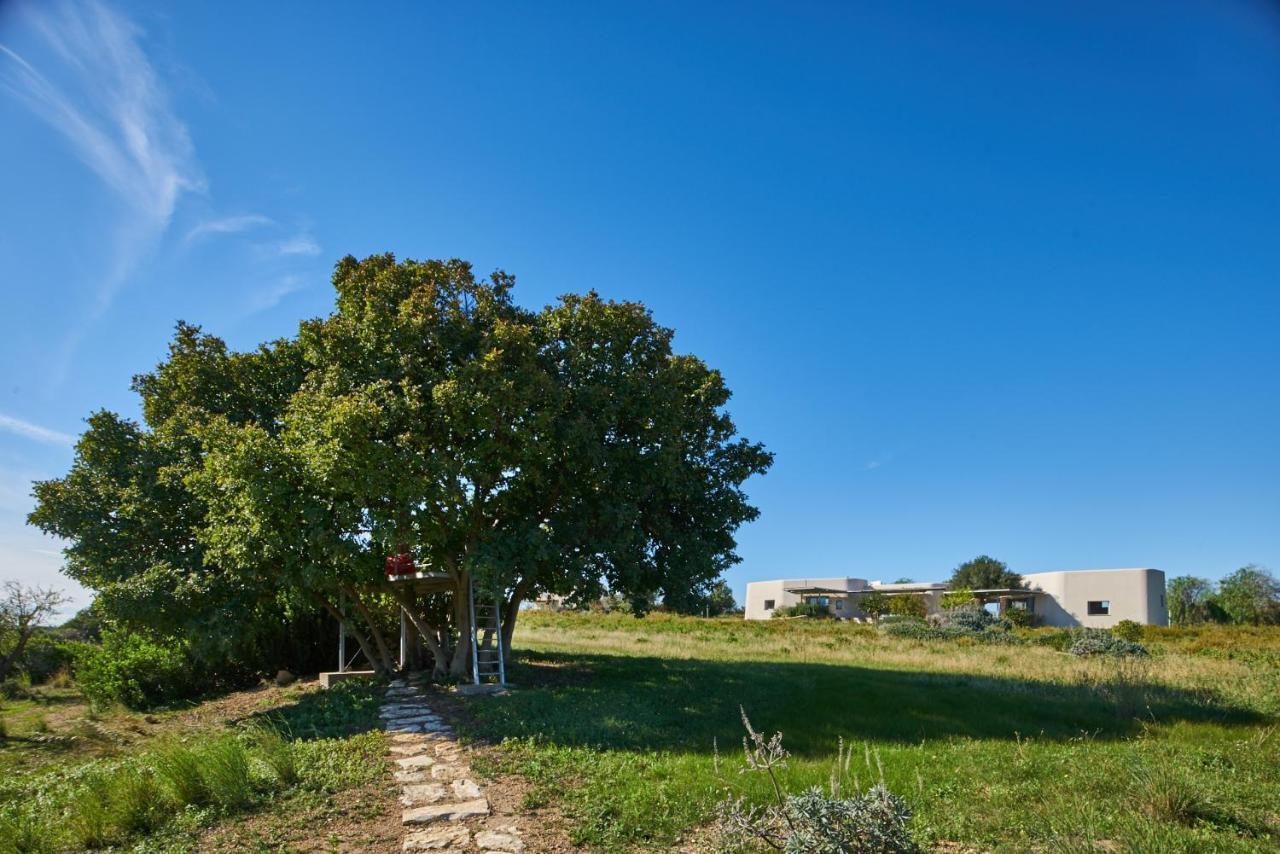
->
[0,682,388,851]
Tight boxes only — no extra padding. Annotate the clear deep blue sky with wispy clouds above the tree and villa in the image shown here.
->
[0,0,1280,614]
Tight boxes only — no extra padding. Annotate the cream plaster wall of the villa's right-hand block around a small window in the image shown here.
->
[1023,568,1169,629]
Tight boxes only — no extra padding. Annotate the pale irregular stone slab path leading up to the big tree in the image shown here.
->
[379,680,525,854]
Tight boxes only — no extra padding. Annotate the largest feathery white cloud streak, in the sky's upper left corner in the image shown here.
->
[0,0,205,384]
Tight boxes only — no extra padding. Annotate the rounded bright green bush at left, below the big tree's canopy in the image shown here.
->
[74,630,202,709]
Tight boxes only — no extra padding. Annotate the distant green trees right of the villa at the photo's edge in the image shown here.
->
[1166,563,1280,626]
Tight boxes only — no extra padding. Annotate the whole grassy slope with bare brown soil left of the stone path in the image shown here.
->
[0,682,399,854]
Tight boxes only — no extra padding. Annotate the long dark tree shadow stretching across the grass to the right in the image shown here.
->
[460,653,1265,755]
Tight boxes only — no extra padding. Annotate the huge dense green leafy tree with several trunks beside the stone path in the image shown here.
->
[31,255,772,675]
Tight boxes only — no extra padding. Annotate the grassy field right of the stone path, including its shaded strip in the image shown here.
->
[465,612,1280,851]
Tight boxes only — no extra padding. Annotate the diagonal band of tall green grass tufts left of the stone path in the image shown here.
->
[0,686,387,854]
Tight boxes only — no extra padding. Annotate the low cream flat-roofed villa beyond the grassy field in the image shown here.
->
[745,568,1169,629]
